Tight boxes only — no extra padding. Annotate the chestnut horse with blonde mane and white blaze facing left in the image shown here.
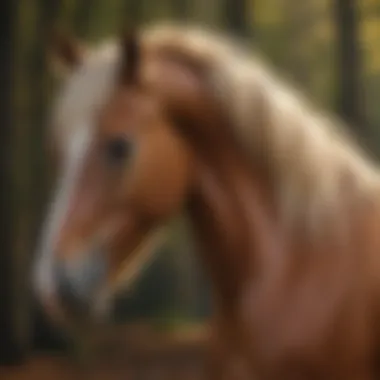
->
[33,23,380,380]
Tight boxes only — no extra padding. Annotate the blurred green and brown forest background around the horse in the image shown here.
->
[0,0,380,380]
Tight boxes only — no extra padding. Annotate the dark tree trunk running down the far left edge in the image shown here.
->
[0,0,24,364]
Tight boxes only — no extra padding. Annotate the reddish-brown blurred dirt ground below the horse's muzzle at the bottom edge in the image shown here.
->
[0,328,207,380]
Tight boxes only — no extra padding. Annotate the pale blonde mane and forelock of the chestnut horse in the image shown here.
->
[52,25,379,235]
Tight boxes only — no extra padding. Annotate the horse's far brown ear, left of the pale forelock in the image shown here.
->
[48,30,85,71]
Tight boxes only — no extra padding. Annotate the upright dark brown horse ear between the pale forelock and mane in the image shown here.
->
[120,29,141,85]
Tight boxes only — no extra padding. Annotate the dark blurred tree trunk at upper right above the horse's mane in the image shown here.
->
[334,0,368,132]
